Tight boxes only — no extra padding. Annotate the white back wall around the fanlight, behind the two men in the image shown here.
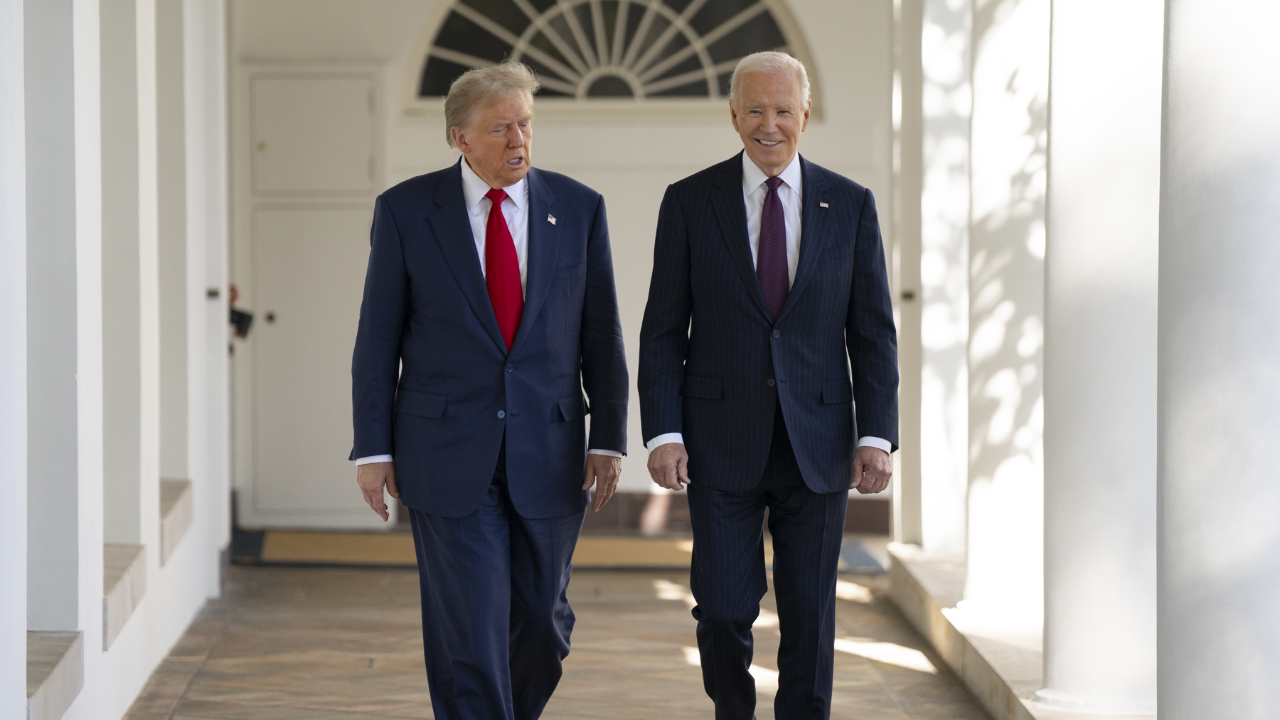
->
[230,0,892,492]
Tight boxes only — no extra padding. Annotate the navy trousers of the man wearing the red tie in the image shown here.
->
[410,443,585,720]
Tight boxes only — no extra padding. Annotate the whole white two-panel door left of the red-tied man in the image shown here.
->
[237,72,385,528]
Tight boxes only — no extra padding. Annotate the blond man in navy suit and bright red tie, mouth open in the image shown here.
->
[351,63,628,720]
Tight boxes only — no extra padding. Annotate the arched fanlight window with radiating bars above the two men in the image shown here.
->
[417,0,812,100]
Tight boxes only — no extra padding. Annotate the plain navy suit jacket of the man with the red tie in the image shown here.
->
[351,160,628,518]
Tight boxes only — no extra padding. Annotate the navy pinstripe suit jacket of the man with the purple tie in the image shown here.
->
[639,148,897,492]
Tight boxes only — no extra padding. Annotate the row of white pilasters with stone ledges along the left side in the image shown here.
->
[0,0,229,719]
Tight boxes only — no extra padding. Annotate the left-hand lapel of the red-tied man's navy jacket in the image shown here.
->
[426,159,507,354]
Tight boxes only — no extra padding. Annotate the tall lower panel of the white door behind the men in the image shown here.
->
[252,204,371,517]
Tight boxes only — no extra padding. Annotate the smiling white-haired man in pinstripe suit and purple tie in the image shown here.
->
[640,53,897,720]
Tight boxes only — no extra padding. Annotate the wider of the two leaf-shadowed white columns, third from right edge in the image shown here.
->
[965,0,1050,617]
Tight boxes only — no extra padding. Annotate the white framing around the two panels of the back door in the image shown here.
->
[228,61,386,529]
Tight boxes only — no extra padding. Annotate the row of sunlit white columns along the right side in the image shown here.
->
[896,0,1280,720]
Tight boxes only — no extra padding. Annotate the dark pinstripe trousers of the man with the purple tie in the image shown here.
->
[687,411,849,720]
